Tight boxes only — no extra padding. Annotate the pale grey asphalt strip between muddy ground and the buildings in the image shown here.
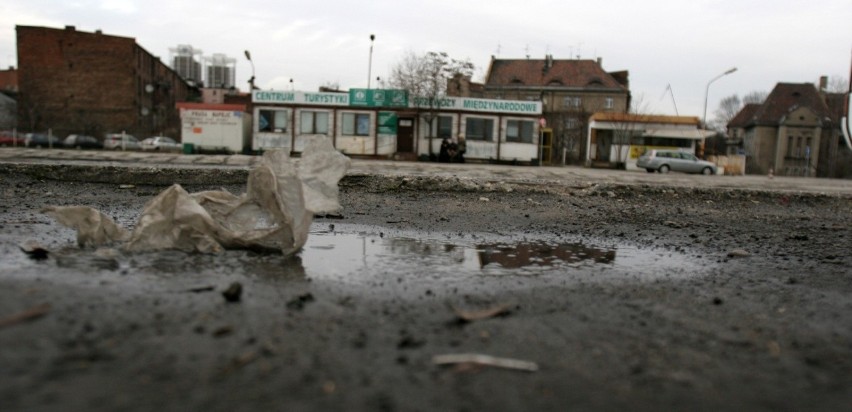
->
[0,147,852,195]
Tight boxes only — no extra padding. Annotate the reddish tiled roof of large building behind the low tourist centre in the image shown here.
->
[485,59,626,91]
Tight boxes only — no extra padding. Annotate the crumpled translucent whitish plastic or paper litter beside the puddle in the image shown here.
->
[43,137,350,255]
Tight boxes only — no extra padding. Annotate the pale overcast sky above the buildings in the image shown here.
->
[0,0,852,120]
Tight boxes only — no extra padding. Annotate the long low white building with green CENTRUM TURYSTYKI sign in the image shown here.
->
[252,89,541,163]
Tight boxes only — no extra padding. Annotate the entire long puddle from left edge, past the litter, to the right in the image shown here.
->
[0,223,706,287]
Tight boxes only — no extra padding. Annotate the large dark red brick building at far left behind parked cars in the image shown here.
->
[16,26,192,137]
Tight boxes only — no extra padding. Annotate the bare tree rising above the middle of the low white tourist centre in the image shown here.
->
[388,51,474,157]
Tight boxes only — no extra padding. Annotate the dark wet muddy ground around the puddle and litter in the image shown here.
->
[0,168,852,411]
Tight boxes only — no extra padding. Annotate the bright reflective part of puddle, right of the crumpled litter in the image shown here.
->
[301,225,700,280]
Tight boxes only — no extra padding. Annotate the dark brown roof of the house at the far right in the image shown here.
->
[754,83,829,124]
